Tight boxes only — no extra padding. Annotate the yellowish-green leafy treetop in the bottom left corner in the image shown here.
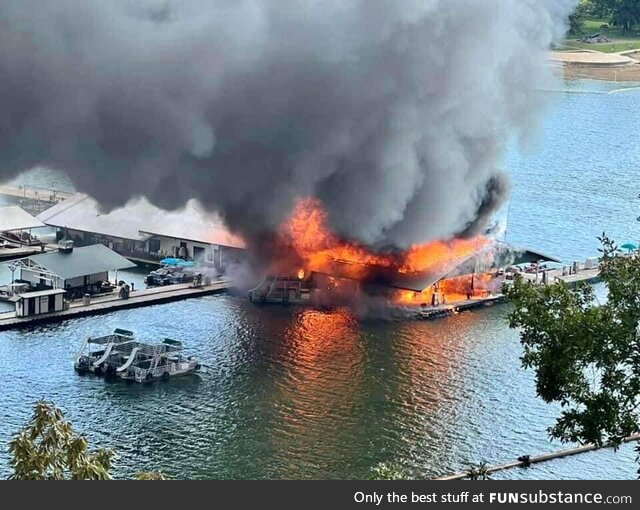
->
[9,401,114,480]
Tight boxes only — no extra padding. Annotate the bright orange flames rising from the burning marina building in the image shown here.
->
[279,198,498,305]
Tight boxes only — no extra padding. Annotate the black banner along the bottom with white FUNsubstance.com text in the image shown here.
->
[1,481,640,510]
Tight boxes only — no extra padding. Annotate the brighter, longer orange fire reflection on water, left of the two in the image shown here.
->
[271,308,367,478]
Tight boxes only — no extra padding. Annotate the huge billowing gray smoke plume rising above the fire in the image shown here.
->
[0,0,577,247]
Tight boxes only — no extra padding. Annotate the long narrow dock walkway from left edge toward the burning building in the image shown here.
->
[0,280,232,331]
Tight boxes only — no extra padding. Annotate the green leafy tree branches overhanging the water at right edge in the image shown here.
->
[505,234,640,446]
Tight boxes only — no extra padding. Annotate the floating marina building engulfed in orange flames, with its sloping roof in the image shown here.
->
[250,198,559,306]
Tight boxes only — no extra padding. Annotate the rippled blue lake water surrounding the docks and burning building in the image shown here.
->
[0,78,640,479]
